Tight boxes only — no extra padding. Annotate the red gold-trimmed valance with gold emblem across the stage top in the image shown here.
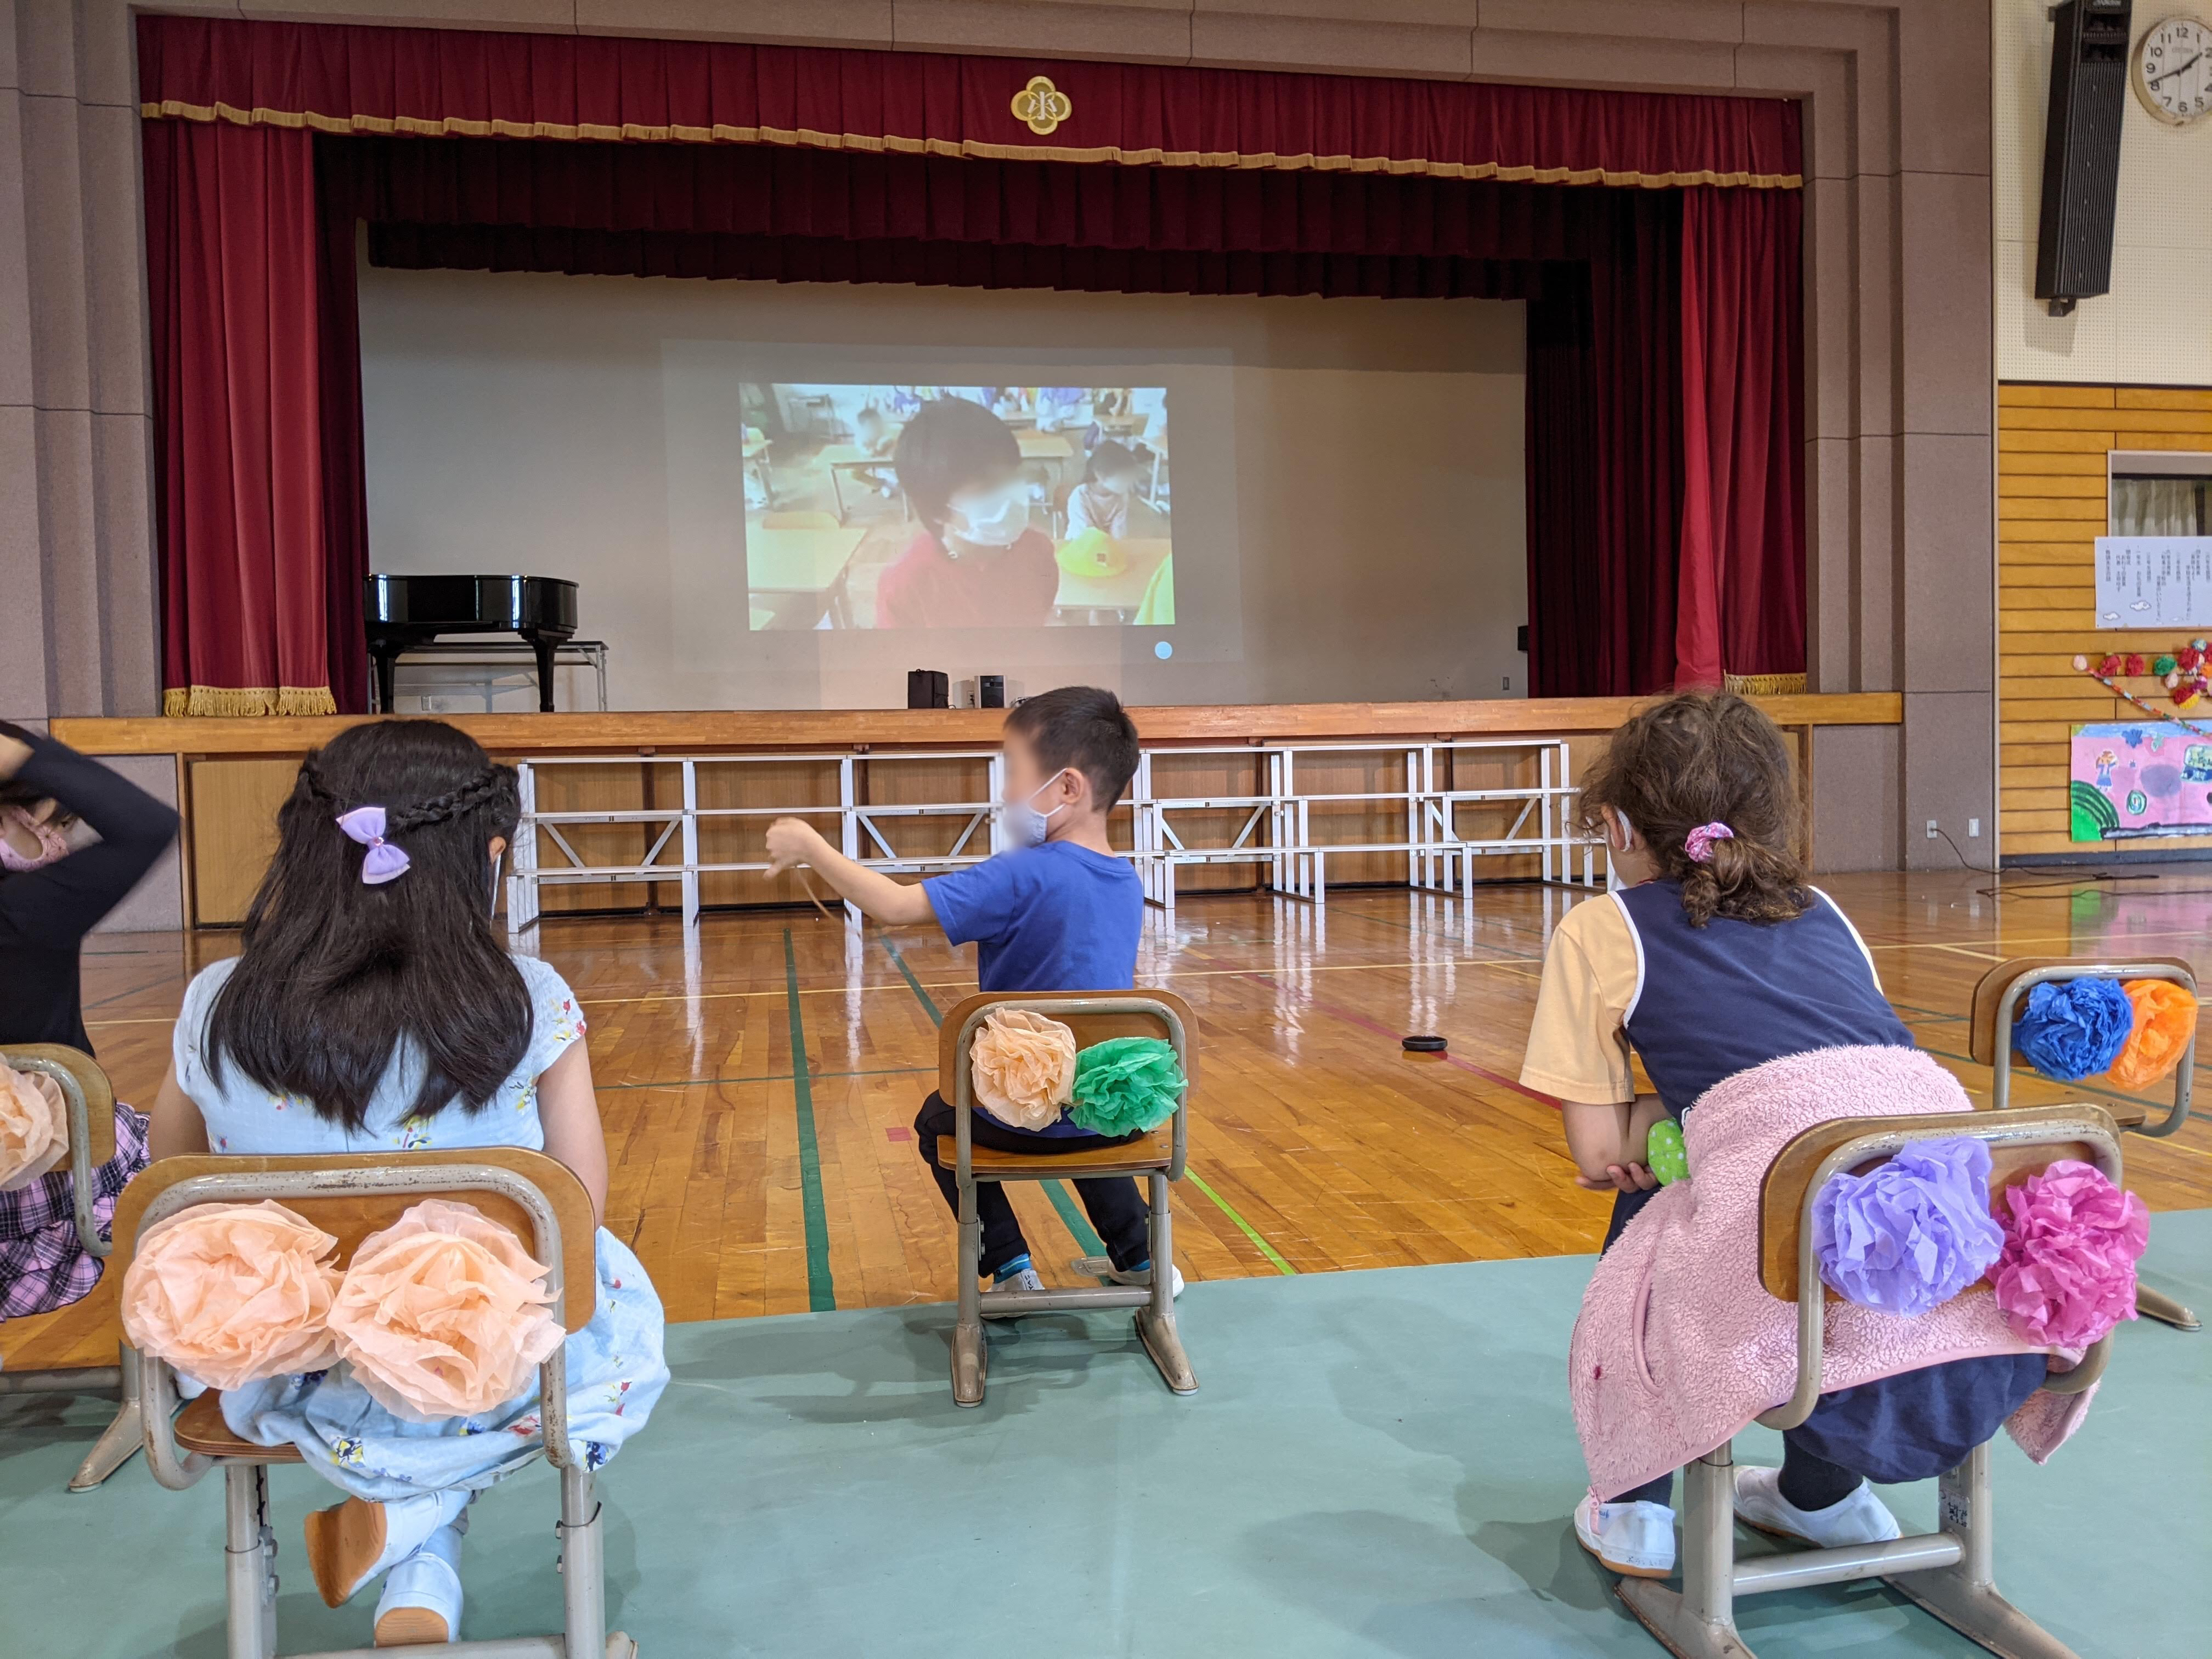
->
[139,15,1801,188]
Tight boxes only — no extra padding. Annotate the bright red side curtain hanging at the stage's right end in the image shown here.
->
[1674,190,1805,690]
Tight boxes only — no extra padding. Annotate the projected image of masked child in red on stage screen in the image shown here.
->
[743,383,1175,628]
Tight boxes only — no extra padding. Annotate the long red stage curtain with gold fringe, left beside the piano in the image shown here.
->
[144,122,336,714]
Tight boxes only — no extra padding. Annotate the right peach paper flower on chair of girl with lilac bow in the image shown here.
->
[330,1199,562,1423]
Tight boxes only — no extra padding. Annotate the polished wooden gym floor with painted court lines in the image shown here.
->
[0,867,2212,1369]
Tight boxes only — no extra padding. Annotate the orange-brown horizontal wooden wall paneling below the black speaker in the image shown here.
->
[1997,385,2212,856]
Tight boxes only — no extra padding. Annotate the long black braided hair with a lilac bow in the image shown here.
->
[206,721,533,1130]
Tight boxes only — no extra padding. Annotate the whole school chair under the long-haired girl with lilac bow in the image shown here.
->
[109,1146,637,1659]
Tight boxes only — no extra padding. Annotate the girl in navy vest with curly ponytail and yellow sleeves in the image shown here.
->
[1522,695,2044,1577]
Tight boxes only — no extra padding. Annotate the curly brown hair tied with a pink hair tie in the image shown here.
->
[1582,692,1812,927]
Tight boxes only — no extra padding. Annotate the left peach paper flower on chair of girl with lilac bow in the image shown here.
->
[122,1199,338,1389]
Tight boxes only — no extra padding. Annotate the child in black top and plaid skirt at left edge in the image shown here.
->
[0,721,177,1321]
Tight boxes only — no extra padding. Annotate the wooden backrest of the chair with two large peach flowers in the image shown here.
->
[109,1146,600,1331]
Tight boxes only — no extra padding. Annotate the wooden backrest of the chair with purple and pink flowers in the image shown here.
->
[1758,1104,2119,1303]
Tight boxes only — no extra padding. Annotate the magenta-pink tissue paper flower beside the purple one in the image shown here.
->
[1989,1159,2150,1347]
